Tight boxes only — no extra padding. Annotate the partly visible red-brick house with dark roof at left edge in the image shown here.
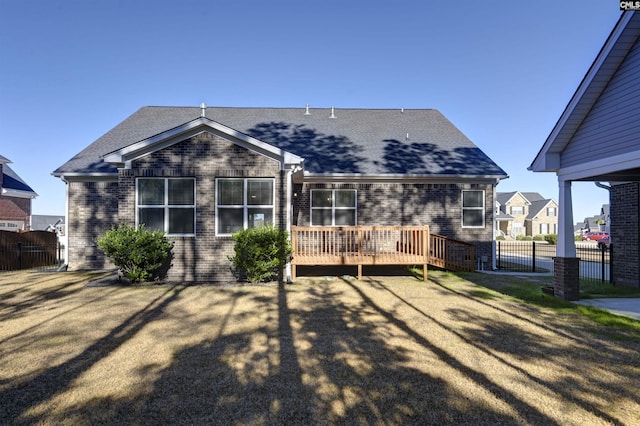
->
[0,155,38,231]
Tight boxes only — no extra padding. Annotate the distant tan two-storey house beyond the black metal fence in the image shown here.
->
[496,191,558,239]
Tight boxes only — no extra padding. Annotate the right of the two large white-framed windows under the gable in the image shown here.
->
[216,179,275,235]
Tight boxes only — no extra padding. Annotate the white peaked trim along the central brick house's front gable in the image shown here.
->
[103,117,304,170]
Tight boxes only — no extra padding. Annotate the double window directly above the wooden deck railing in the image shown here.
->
[311,189,357,226]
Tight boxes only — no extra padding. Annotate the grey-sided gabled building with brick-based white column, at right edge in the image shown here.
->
[529,12,640,300]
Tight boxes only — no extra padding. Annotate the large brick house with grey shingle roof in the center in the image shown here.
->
[53,104,507,281]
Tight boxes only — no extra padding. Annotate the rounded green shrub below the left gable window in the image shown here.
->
[97,224,172,283]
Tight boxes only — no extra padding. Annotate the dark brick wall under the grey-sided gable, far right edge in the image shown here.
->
[610,182,640,287]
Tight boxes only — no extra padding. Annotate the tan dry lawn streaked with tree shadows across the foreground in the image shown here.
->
[0,272,640,424]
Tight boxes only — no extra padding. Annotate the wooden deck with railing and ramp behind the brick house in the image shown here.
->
[291,226,474,281]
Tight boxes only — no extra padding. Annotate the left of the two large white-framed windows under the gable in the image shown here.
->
[136,178,196,235]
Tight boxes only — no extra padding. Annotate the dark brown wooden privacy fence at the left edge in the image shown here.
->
[0,231,59,271]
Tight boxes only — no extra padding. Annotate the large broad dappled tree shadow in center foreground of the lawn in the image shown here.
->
[20,281,524,425]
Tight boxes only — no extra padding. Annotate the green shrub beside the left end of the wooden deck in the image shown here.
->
[229,226,291,283]
